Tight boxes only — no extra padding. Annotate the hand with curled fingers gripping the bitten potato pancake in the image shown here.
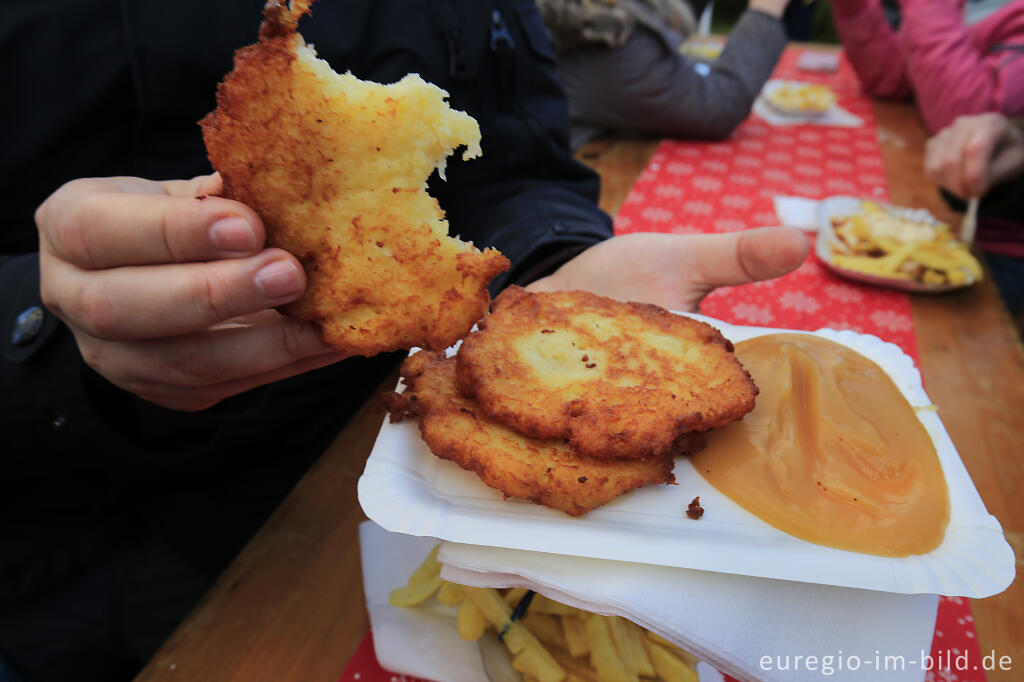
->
[36,174,341,411]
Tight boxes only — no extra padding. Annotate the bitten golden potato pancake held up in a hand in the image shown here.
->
[201,0,509,355]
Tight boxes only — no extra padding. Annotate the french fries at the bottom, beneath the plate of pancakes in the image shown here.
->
[390,548,697,682]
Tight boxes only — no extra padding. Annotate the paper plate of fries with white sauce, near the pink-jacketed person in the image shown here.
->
[815,197,983,293]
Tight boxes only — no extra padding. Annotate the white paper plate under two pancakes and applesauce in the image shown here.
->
[358,315,1015,598]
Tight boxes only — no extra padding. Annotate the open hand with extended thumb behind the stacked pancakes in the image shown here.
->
[526,227,810,311]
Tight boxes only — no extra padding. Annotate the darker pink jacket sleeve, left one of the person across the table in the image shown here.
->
[833,0,911,97]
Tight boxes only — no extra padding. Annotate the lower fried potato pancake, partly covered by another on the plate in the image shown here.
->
[388,351,696,516]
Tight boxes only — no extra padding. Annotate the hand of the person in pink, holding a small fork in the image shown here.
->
[925,114,1024,199]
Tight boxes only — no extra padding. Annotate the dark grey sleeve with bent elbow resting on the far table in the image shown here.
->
[558,10,785,139]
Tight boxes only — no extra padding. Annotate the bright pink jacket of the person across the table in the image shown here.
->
[834,0,1024,133]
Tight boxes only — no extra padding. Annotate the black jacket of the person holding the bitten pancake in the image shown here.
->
[0,0,610,608]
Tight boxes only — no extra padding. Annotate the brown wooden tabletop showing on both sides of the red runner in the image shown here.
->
[137,102,1024,682]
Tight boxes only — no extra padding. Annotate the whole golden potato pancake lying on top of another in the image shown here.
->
[458,287,758,459]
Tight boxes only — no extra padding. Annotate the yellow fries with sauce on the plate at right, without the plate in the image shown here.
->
[830,202,982,285]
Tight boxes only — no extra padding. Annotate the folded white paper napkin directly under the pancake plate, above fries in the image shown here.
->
[438,543,938,682]
